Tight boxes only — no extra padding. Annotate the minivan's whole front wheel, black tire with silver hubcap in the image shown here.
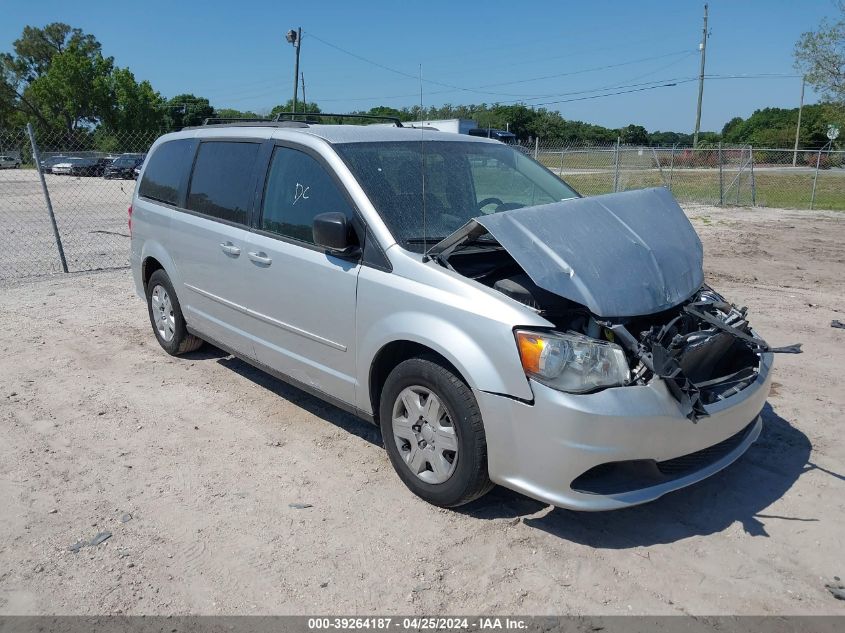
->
[379,357,493,507]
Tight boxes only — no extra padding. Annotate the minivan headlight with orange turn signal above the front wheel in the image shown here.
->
[515,330,630,393]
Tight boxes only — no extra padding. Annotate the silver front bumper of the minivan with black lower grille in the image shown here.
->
[477,354,772,510]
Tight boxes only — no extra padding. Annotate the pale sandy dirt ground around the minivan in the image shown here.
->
[0,207,845,615]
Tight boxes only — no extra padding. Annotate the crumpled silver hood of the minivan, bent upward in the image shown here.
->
[430,187,704,317]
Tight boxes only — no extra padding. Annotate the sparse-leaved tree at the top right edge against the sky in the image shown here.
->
[795,0,845,103]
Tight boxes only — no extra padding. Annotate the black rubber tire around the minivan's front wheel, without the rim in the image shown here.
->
[379,356,493,508]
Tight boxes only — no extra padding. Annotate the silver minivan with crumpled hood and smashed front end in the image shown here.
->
[129,121,777,510]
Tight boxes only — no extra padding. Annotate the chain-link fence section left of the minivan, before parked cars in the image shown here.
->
[0,128,158,279]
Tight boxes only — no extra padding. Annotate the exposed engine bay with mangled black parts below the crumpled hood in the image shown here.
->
[438,241,800,421]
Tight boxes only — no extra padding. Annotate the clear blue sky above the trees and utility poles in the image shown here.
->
[0,0,835,131]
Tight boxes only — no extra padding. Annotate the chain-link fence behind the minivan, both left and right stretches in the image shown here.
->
[0,128,845,279]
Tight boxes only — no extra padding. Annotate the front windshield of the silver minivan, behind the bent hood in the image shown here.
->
[335,141,578,251]
